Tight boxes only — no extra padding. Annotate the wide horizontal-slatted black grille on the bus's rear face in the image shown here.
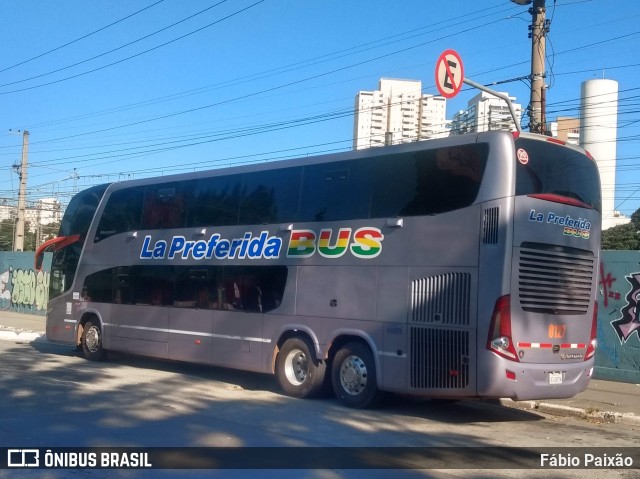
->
[518,243,595,315]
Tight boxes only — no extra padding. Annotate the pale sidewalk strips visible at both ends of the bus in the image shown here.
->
[0,311,640,426]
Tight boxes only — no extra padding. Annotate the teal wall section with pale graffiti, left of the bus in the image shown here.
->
[0,251,51,316]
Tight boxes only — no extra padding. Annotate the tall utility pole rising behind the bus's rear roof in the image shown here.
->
[511,0,549,133]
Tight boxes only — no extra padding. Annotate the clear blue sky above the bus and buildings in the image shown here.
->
[0,0,640,215]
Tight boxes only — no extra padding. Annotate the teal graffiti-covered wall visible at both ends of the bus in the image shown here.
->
[0,251,640,384]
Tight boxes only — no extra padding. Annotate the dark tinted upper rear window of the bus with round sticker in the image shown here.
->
[516,138,601,211]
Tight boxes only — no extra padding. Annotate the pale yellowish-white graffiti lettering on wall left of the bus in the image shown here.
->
[0,266,50,313]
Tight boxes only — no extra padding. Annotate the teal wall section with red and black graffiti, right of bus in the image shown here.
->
[594,251,640,384]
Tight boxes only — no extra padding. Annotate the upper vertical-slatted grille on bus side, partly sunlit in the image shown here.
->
[411,273,471,325]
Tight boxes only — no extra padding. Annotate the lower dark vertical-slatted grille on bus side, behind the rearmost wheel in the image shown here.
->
[410,327,469,389]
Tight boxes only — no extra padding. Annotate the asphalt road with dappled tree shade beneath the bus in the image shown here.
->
[0,340,640,479]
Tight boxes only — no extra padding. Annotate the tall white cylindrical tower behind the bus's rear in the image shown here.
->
[580,79,625,229]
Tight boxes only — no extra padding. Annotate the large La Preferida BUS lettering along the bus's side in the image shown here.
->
[140,227,384,260]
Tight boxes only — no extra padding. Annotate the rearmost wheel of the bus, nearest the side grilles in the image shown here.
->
[331,342,379,409]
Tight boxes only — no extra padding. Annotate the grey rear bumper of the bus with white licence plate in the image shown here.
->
[478,359,594,401]
